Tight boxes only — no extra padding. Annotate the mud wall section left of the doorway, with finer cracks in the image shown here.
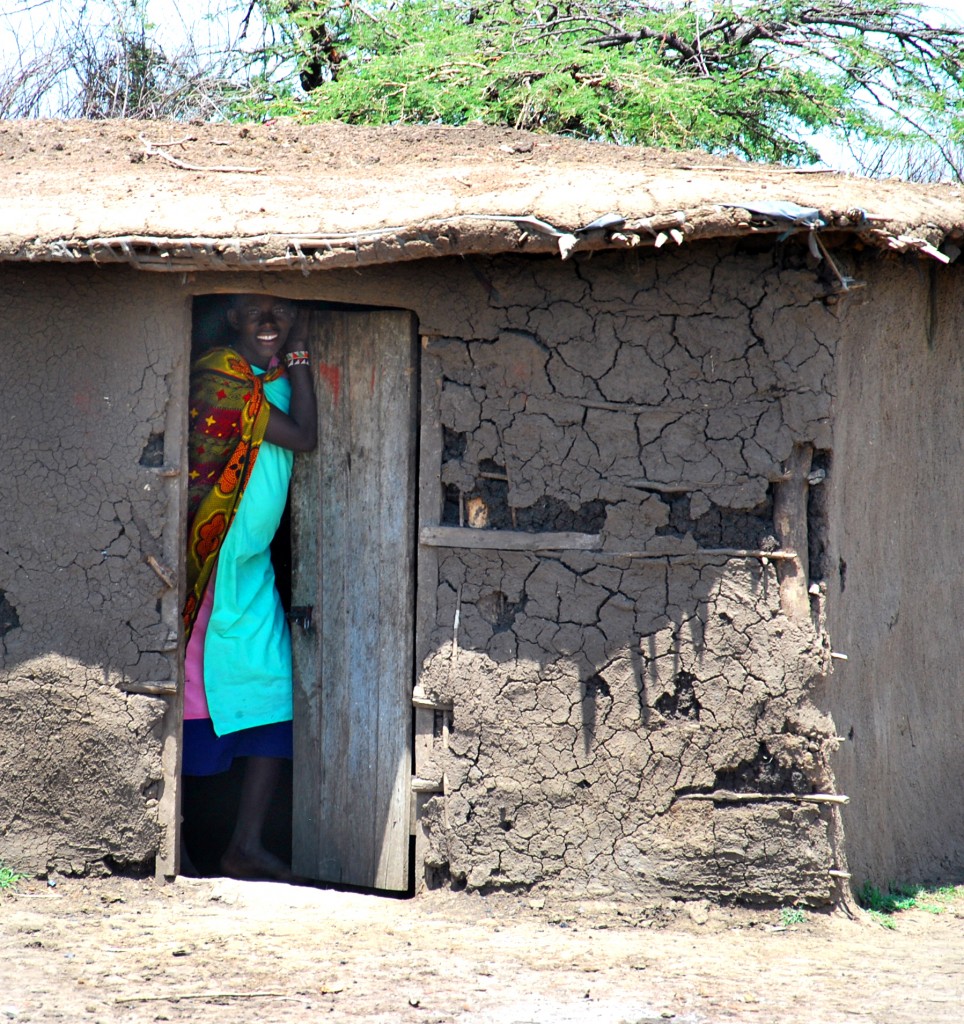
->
[0,265,190,873]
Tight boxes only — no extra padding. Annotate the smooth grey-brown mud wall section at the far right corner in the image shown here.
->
[822,258,964,886]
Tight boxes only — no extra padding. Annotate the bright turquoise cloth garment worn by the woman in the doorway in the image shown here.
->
[204,367,294,736]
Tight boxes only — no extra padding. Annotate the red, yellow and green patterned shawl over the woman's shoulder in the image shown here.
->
[183,348,284,637]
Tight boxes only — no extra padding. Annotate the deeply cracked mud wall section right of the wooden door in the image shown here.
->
[391,247,841,904]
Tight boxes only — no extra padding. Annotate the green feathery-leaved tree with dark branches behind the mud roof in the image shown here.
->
[231,0,964,176]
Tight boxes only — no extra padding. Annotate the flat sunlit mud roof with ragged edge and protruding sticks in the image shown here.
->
[0,121,964,272]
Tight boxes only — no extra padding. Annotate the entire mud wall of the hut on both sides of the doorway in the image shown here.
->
[0,244,946,904]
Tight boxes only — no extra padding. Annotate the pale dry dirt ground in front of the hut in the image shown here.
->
[0,878,964,1024]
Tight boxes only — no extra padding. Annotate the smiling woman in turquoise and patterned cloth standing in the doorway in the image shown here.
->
[182,295,318,880]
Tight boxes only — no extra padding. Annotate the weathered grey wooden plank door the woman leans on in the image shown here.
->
[292,311,418,890]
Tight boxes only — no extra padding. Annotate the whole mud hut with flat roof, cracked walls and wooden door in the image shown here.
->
[0,122,964,905]
